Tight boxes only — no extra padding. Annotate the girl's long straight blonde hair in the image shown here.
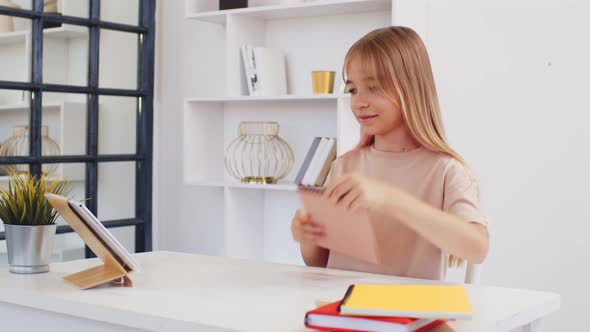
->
[342,26,465,266]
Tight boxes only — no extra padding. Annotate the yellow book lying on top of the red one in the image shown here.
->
[340,284,473,319]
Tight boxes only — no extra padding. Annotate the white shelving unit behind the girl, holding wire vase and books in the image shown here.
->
[183,0,393,264]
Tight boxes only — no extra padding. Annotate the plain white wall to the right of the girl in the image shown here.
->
[428,0,590,331]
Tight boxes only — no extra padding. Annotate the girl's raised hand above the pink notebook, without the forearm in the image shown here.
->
[324,173,396,211]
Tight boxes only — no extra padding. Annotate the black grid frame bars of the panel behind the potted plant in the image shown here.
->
[0,0,156,256]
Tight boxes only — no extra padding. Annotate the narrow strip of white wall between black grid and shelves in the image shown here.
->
[154,0,225,254]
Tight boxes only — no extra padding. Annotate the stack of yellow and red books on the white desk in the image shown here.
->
[305,284,472,332]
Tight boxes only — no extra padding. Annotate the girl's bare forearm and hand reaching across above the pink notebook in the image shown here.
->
[325,174,489,264]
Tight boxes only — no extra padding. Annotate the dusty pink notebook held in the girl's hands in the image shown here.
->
[299,187,381,264]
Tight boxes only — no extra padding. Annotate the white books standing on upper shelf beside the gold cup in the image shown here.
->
[240,45,287,96]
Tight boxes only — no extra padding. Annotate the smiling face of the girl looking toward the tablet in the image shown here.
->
[346,57,404,136]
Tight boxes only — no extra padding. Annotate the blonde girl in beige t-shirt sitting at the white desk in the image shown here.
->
[291,27,489,280]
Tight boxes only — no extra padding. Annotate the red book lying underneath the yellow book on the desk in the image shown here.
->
[305,301,444,332]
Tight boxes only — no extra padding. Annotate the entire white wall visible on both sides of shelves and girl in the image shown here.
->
[154,0,590,331]
